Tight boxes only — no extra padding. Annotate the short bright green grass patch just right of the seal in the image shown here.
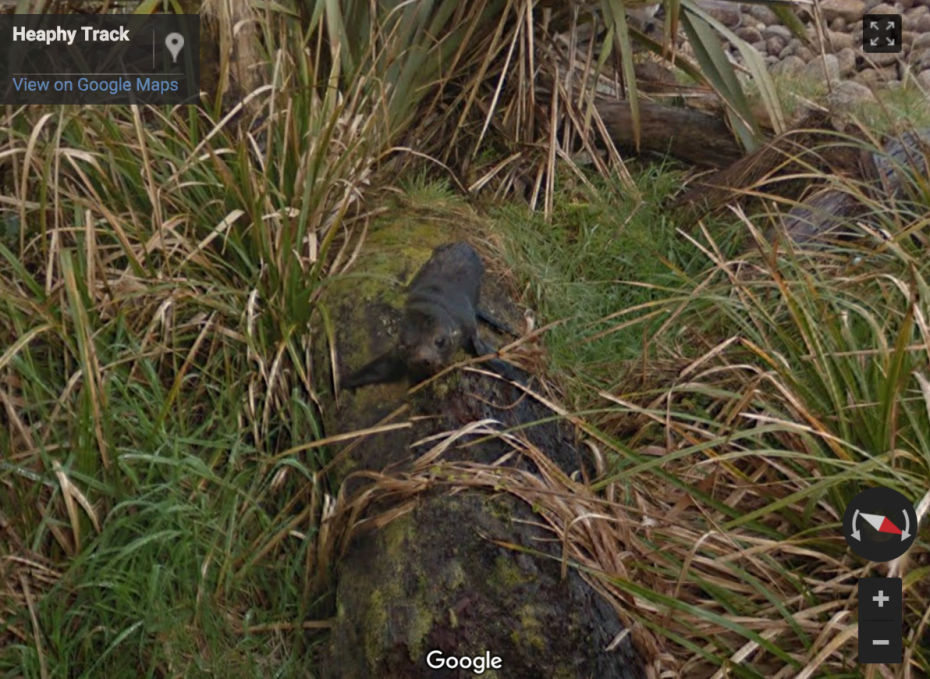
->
[494,163,741,395]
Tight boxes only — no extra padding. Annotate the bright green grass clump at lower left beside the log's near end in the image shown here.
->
[11,446,316,677]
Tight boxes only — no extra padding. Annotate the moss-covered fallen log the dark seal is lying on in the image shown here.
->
[320,227,646,679]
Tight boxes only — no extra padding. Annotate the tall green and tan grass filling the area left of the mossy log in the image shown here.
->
[0,7,392,677]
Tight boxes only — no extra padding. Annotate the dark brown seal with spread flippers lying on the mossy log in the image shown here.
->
[342,242,516,389]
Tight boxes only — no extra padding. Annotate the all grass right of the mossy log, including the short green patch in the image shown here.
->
[478,132,930,677]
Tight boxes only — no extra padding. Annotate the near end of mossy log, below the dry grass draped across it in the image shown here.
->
[320,493,645,679]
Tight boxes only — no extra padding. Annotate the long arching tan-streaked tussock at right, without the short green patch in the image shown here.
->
[576,174,930,677]
